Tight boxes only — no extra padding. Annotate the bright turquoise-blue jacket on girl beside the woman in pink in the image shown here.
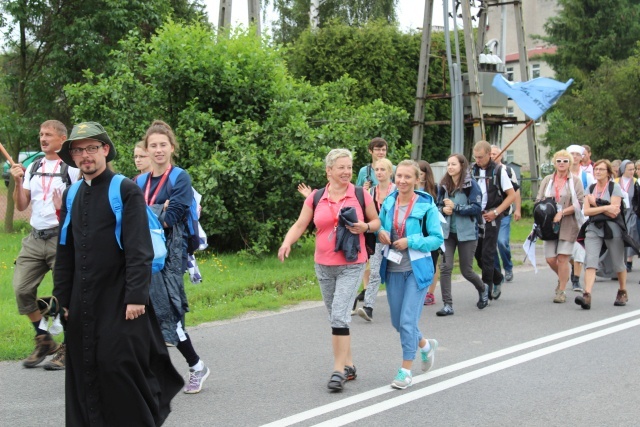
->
[380,190,444,289]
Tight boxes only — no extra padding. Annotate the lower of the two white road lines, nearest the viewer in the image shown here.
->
[315,319,640,427]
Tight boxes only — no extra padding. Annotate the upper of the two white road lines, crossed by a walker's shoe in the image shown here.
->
[263,310,640,427]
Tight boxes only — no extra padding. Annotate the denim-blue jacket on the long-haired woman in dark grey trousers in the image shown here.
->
[438,175,482,242]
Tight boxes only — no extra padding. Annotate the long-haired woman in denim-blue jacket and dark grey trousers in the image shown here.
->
[436,154,489,316]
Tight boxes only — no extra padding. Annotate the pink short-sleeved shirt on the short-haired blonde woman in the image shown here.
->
[304,184,373,265]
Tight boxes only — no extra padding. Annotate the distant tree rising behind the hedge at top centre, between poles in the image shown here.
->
[264,0,398,44]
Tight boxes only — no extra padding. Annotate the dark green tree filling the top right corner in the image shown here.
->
[540,0,640,83]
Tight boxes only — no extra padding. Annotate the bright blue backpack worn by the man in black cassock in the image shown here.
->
[59,175,167,274]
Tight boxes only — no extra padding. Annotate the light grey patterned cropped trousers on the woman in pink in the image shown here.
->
[315,263,367,328]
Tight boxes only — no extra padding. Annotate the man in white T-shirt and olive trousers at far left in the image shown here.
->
[11,120,78,370]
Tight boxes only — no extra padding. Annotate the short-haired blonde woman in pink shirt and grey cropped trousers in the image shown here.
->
[278,148,380,391]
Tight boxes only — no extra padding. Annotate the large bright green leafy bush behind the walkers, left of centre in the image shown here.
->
[66,23,409,254]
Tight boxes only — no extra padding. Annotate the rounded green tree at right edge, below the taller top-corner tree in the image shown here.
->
[545,50,640,159]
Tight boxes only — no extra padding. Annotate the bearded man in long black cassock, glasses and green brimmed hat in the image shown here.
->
[53,122,183,426]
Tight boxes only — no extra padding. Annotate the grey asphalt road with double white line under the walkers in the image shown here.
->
[0,268,640,427]
